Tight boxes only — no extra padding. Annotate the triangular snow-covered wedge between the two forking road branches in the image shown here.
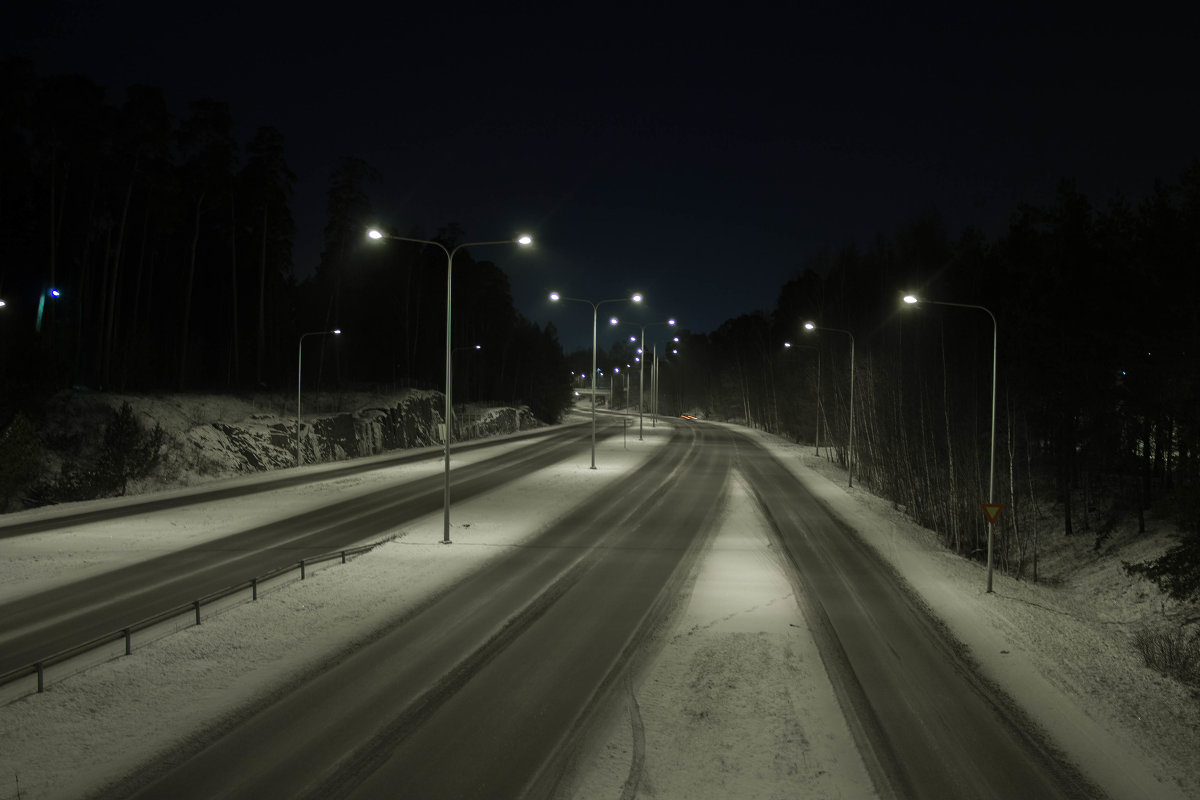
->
[571,480,876,800]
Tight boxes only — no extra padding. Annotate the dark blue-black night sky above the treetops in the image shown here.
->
[0,0,1200,349]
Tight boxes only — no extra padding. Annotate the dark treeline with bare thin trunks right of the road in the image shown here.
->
[633,175,1200,597]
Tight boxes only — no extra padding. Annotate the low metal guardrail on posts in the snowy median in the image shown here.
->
[0,540,389,705]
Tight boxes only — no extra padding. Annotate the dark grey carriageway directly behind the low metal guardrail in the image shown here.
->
[0,426,612,673]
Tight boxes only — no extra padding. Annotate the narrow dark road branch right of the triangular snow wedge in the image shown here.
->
[738,444,1103,800]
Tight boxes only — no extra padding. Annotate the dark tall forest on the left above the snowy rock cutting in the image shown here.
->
[0,60,569,425]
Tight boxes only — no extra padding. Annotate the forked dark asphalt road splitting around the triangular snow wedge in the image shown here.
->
[7,423,1103,800]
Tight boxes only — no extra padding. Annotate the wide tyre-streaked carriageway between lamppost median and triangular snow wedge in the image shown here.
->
[114,426,732,798]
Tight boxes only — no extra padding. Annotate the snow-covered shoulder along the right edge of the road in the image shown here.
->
[764,437,1200,800]
